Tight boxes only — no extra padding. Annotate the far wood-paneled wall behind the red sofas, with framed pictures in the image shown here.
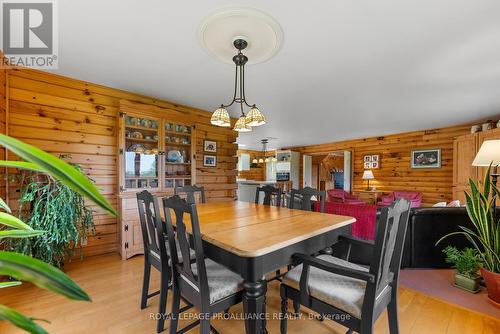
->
[291,125,470,206]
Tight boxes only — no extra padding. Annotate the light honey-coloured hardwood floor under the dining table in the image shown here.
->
[0,254,500,334]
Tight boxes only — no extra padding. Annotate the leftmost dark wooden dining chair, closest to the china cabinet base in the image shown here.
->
[137,190,172,333]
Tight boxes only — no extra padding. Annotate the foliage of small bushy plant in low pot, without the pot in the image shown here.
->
[443,246,481,279]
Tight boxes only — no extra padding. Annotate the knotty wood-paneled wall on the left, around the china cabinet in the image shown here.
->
[0,69,237,255]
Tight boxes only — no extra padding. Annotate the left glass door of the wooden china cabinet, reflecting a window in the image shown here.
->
[124,116,159,189]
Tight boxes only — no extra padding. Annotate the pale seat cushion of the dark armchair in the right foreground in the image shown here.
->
[283,255,368,319]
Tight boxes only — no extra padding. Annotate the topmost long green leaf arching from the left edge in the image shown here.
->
[0,134,117,217]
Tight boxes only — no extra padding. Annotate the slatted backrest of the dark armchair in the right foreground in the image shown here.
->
[370,199,410,295]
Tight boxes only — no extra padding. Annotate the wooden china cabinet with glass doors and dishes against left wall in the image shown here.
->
[118,103,196,259]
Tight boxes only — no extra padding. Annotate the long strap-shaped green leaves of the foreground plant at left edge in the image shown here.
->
[0,134,116,334]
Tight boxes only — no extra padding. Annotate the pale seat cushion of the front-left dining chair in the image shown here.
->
[191,259,243,304]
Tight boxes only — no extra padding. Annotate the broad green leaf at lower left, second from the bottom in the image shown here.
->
[0,252,90,301]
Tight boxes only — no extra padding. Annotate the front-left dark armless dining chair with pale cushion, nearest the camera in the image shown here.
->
[163,195,243,334]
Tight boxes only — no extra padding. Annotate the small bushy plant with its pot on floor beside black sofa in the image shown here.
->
[443,246,481,293]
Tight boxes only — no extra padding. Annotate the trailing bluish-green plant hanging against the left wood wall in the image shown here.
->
[7,166,94,267]
